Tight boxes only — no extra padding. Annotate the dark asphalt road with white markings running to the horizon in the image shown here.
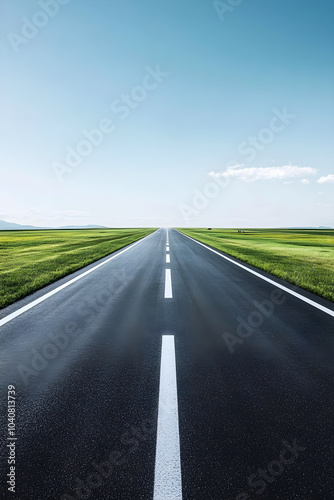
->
[0,229,334,500]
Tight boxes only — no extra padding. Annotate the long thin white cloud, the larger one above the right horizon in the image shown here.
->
[209,165,316,182]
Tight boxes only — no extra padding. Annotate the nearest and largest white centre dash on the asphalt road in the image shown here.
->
[153,335,182,500]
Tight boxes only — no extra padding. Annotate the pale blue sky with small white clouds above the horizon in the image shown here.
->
[0,0,334,227]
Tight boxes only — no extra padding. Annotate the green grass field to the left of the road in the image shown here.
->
[0,228,154,309]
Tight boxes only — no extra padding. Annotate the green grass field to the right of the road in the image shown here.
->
[180,229,334,302]
